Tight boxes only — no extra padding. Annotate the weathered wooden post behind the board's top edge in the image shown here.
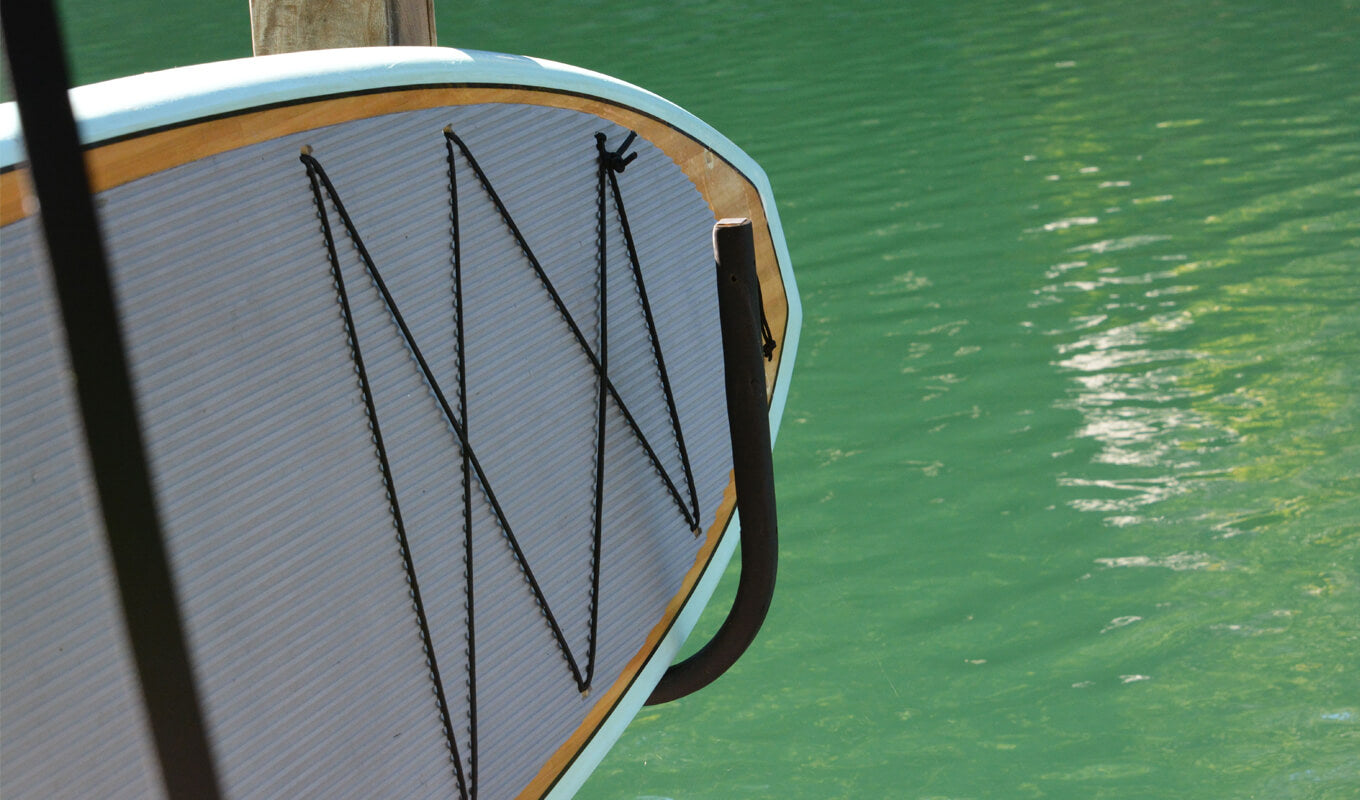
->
[250,0,437,56]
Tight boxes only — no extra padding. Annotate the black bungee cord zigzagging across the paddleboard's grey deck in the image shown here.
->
[301,128,699,800]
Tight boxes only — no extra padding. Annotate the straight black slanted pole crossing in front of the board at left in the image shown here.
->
[0,0,222,800]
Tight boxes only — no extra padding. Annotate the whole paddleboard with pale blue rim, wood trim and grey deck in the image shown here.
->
[0,48,801,797]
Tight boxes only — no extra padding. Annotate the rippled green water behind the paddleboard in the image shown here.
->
[13,0,1360,800]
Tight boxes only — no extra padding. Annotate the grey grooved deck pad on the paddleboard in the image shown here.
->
[0,103,732,799]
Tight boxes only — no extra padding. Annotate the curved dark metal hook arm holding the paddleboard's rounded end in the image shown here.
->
[647,219,779,706]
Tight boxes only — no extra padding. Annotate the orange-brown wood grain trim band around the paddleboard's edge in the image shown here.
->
[0,87,789,799]
